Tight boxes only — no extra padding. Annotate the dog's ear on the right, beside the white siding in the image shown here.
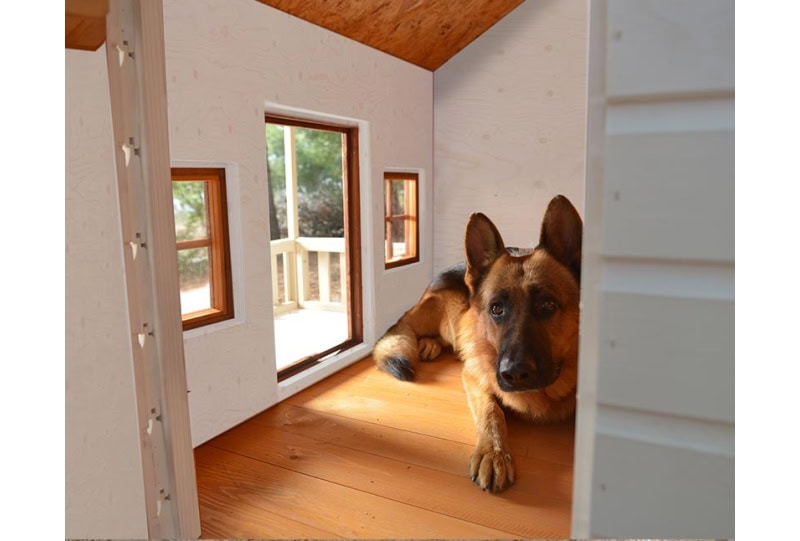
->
[539,195,583,283]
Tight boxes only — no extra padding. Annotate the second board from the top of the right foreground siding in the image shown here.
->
[603,131,734,261]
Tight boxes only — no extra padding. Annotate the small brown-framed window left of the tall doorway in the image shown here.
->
[172,167,233,330]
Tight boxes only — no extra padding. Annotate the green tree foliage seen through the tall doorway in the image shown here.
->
[266,124,344,239]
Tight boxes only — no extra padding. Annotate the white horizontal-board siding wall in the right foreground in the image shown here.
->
[573,0,735,538]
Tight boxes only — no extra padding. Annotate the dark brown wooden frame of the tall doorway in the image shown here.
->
[264,113,364,382]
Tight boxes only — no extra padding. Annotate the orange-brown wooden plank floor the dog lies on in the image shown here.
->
[195,354,574,539]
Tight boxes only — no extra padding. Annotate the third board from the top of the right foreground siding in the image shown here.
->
[597,293,734,423]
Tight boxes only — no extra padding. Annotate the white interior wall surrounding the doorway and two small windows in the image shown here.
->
[164,0,433,444]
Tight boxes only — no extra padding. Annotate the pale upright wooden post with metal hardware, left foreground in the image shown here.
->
[106,0,200,538]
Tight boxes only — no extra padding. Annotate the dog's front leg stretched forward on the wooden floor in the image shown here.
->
[462,370,515,492]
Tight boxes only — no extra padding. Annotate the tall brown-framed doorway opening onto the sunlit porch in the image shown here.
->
[265,115,363,381]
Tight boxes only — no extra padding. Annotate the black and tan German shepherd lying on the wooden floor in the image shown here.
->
[373,195,583,492]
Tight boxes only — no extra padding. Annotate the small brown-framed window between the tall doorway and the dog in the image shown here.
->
[383,173,419,269]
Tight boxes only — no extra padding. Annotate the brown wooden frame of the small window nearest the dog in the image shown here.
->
[383,171,419,269]
